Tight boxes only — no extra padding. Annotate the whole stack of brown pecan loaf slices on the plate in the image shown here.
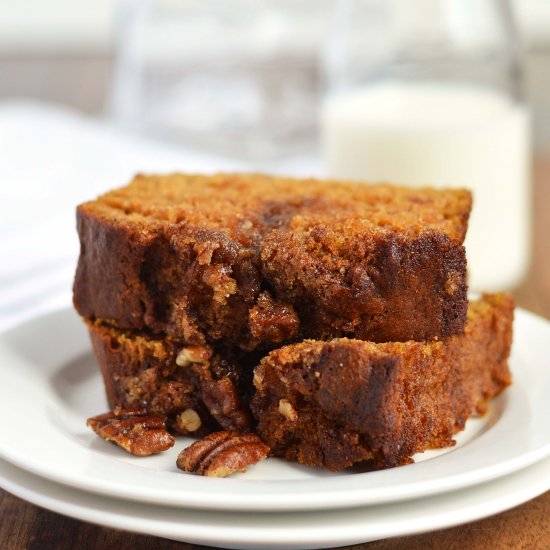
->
[74,174,513,470]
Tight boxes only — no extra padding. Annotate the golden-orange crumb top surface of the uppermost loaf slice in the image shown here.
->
[88,174,471,240]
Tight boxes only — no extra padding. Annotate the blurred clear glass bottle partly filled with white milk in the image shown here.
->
[321,0,531,291]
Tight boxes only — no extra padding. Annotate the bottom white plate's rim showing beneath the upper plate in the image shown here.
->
[0,458,550,550]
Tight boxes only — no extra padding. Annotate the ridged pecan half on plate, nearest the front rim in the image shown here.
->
[176,432,269,477]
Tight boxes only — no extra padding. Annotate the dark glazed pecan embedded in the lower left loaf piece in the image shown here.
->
[201,376,251,432]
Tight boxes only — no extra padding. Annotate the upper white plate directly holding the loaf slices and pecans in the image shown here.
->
[0,310,550,511]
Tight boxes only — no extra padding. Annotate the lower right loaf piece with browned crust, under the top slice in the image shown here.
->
[252,295,513,470]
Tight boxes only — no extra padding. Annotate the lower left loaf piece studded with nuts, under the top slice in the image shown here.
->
[87,321,259,435]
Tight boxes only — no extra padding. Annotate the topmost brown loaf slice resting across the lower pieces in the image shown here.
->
[74,174,471,350]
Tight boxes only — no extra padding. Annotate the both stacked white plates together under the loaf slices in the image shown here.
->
[0,310,550,549]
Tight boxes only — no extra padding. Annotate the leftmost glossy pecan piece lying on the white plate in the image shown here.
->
[86,407,174,456]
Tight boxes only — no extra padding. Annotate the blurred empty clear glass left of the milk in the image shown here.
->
[113,0,330,159]
